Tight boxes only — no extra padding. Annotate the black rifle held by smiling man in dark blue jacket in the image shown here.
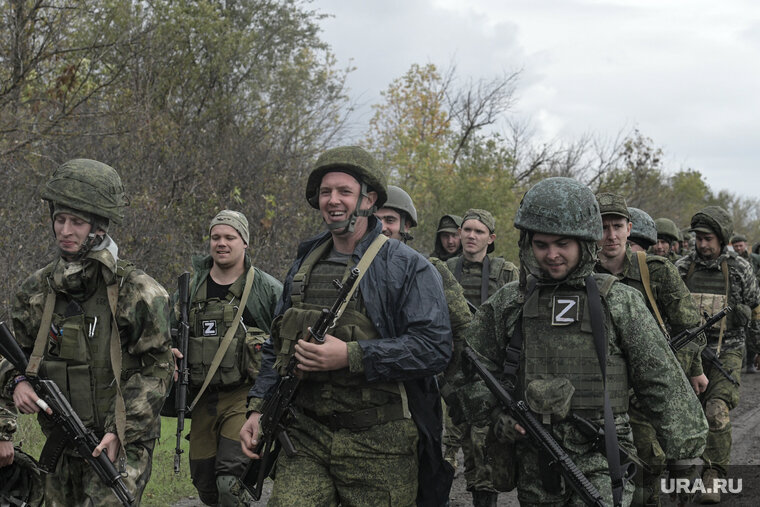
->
[240,268,359,500]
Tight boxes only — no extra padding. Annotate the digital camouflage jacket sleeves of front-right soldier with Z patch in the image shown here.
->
[452,282,707,459]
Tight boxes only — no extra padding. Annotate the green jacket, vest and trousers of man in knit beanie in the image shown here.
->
[174,246,282,505]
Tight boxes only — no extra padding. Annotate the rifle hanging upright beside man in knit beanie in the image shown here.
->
[174,271,190,474]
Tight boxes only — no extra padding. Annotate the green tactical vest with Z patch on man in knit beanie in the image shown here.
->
[187,276,249,389]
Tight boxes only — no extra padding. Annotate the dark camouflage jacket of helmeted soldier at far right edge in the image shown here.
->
[676,248,760,353]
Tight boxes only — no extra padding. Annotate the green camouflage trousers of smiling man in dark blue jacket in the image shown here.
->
[268,414,418,507]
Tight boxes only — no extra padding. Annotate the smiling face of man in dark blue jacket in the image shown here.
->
[319,171,377,231]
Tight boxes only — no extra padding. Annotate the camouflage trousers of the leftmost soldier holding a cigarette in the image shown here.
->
[45,440,154,507]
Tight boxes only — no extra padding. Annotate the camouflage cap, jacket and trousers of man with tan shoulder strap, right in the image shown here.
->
[596,194,705,506]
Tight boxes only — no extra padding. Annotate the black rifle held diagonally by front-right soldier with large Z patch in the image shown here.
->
[462,347,606,507]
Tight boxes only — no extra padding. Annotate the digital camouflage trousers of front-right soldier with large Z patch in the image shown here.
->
[515,416,635,507]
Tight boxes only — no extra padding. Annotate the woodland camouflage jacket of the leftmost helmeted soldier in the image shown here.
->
[0,246,174,443]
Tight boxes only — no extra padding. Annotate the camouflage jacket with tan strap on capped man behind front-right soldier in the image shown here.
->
[596,246,706,377]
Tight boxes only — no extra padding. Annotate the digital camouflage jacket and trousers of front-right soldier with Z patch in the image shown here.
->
[450,236,707,505]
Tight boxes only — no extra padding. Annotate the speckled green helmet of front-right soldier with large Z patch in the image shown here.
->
[515,177,602,241]
